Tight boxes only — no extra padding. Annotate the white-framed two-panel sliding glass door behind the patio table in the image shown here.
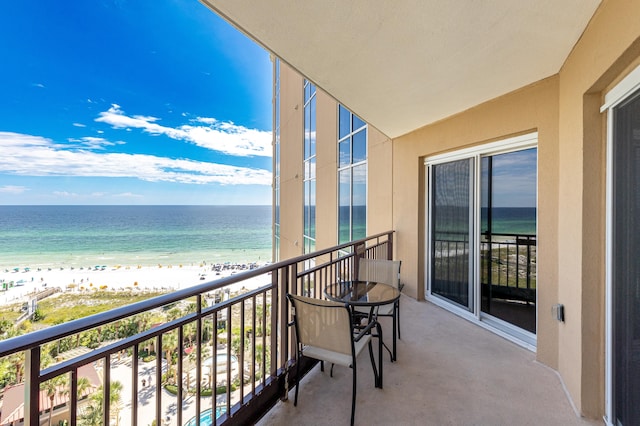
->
[426,134,537,346]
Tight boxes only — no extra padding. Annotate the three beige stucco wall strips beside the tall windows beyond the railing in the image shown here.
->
[280,63,393,259]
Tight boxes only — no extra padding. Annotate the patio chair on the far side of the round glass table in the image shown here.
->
[355,258,403,361]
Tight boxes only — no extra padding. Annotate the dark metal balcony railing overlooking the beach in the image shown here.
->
[0,232,393,426]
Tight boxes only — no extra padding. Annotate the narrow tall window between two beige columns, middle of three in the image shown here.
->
[303,80,316,253]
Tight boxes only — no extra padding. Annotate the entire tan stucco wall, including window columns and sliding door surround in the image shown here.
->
[281,0,640,418]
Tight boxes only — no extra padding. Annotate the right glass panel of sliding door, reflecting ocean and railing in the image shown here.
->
[480,148,537,333]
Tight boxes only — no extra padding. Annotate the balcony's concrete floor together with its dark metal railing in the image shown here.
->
[0,232,589,426]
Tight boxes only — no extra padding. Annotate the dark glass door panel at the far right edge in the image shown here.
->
[612,88,640,425]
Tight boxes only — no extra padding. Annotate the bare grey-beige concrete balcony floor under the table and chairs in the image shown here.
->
[258,296,602,426]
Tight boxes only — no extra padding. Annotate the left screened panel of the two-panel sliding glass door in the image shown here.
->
[430,159,473,311]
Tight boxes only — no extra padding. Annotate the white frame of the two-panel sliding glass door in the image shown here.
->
[424,132,538,352]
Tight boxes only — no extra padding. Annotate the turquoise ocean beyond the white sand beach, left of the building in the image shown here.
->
[0,206,272,269]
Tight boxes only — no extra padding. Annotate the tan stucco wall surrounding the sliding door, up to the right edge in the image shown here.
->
[393,0,640,418]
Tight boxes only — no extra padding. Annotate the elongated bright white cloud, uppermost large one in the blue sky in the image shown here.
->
[96,104,271,157]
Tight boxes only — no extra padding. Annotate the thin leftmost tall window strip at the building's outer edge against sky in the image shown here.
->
[273,58,280,262]
